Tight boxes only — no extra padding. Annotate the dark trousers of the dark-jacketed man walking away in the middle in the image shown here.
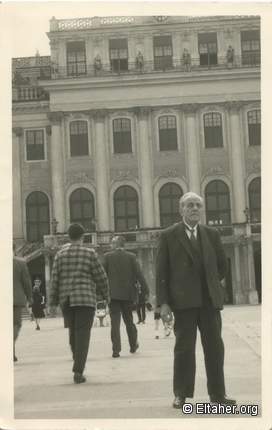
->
[109,299,137,353]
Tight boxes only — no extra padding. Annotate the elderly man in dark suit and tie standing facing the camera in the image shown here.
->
[156,192,236,409]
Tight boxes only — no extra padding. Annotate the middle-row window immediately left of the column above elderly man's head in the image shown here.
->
[159,115,178,151]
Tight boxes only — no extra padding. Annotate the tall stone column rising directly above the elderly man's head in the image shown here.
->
[181,104,200,195]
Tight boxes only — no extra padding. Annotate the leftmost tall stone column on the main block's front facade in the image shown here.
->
[47,112,67,232]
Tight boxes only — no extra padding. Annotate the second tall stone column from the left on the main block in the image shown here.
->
[90,109,110,230]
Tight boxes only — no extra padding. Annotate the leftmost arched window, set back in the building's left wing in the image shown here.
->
[26,191,50,242]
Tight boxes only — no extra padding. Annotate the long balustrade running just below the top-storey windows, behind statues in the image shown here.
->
[48,54,260,79]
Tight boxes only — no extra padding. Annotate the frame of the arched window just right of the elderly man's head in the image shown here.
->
[204,179,231,226]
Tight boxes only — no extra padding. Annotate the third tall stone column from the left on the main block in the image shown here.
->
[136,107,155,227]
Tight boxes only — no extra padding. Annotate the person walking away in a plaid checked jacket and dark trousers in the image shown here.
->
[49,223,109,384]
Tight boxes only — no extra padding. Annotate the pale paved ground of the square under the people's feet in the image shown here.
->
[9,305,262,429]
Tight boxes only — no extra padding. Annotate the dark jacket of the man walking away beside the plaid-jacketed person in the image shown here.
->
[104,249,149,302]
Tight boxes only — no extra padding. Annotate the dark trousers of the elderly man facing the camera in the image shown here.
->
[174,297,225,398]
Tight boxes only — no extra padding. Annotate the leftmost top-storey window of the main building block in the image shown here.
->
[66,41,86,76]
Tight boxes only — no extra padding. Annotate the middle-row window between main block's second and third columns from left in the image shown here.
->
[113,118,132,154]
